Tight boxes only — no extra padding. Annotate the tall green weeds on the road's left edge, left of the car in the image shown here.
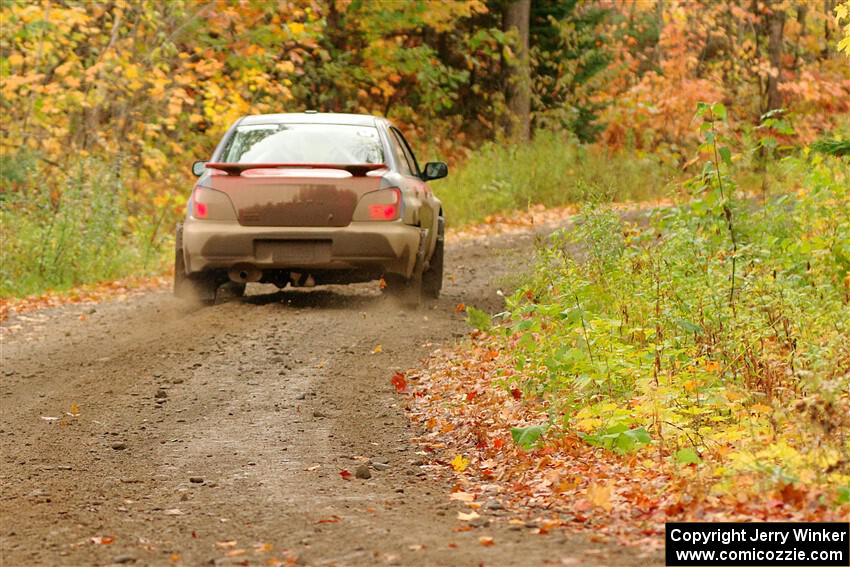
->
[0,155,169,297]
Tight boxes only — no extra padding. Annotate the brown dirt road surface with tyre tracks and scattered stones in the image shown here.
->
[0,230,657,566]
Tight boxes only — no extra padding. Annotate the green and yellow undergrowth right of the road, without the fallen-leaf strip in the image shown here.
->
[503,154,850,496]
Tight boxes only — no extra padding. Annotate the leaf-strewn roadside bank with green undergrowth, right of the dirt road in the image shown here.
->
[400,151,850,541]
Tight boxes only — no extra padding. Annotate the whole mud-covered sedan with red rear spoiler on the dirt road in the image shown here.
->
[175,113,446,304]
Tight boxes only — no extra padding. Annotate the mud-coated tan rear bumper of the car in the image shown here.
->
[183,219,421,277]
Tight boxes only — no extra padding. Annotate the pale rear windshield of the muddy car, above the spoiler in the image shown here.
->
[222,124,385,165]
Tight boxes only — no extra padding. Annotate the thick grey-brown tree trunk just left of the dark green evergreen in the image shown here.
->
[502,0,531,141]
